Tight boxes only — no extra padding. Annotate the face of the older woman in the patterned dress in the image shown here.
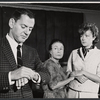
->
[50,42,64,60]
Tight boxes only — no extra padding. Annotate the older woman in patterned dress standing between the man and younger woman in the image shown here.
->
[43,39,74,98]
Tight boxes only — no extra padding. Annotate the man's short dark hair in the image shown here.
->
[11,9,35,21]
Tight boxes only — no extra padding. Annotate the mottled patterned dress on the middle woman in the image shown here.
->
[43,59,66,98]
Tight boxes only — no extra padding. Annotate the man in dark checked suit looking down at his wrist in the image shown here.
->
[0,9,50,98]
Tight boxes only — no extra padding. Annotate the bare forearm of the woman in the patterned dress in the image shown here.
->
[51,77,74,90]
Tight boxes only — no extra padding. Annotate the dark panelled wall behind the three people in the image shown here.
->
[0,4,83,62]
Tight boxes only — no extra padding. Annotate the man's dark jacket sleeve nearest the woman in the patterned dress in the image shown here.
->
[35,51,50,84]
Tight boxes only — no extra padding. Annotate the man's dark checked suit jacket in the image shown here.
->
[0,37,50,98]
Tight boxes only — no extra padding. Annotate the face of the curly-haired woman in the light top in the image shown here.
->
[80,30,95,48]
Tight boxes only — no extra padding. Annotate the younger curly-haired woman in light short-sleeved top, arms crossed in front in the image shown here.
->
[67,23,100,98]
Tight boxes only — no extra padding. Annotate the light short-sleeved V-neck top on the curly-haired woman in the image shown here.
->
[67,47,100,93]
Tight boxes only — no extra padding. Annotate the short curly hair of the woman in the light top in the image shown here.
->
[79,23,99,45]
